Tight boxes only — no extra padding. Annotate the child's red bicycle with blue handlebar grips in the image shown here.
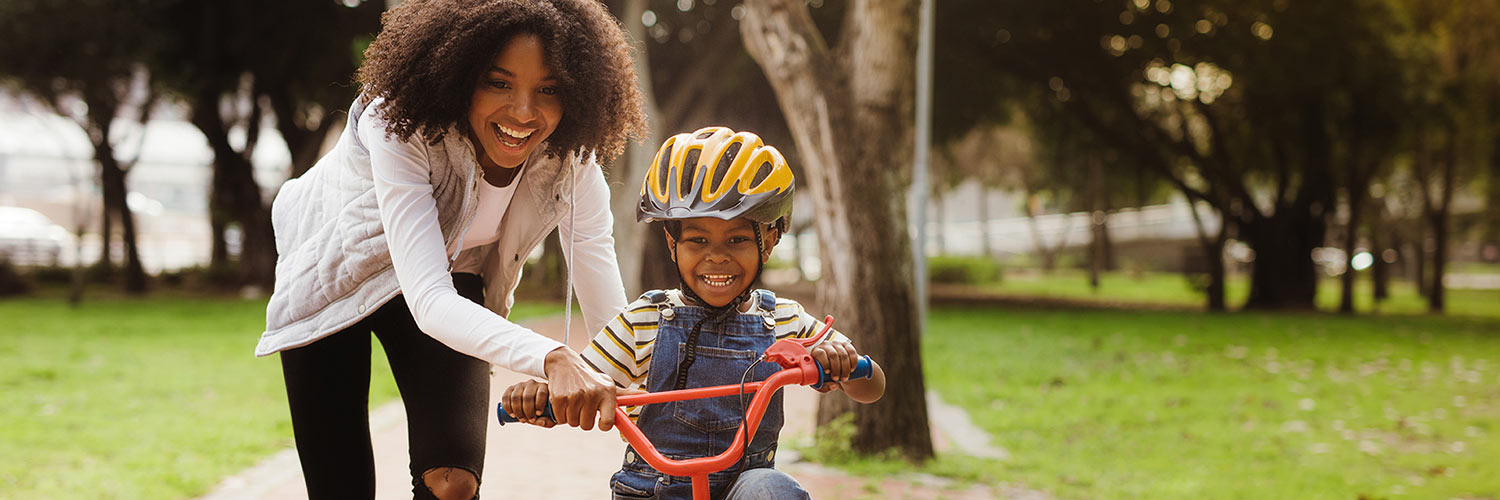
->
[495,315,873,500]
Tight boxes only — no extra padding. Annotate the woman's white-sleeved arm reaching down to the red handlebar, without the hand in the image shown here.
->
[357,102,563,377]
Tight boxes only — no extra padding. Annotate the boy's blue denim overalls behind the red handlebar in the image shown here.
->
[609,290,782,498]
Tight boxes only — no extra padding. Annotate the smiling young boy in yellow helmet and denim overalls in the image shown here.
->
[503,126,885,498]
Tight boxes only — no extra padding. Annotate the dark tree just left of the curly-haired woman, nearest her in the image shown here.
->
[158,0,384,287]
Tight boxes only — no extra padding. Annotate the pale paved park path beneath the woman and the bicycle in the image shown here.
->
[201,317,1026,500]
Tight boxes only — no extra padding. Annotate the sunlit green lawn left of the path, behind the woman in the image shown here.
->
[0,291,558,498]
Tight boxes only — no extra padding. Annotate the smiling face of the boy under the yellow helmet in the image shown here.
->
[666,218,780,308]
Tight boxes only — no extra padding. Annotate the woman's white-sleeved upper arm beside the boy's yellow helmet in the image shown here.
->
[558,153,626,333]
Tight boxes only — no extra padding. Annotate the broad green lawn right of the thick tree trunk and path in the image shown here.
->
[923,308,1500,498]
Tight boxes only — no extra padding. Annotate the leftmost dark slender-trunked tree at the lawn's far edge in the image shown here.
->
[0,0,161,293]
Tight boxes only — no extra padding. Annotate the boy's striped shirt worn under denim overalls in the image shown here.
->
[584,288,849,419]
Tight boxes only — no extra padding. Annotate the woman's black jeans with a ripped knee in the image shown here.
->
[281,273,489,500]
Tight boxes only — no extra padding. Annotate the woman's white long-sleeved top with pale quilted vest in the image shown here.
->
[257,101,626,377]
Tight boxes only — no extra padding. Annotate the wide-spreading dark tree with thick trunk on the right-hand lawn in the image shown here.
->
[938,0,1403,308]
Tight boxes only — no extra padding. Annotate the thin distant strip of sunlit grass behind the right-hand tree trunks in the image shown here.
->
[981,270,1500,317]
